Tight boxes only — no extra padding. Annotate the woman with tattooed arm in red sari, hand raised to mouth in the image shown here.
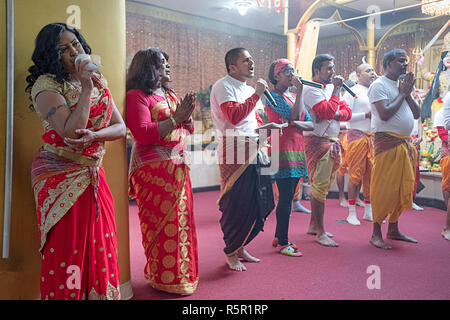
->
[26,23,126,300]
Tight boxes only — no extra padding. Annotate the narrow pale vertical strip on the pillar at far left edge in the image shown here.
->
[2,0,14,259]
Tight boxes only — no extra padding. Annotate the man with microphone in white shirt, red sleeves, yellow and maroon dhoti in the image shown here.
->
[303,54,352,247]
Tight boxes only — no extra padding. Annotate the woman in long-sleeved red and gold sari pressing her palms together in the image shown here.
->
[126,48,198,294]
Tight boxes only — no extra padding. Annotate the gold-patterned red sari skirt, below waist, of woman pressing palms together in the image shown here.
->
[131,160,198,294]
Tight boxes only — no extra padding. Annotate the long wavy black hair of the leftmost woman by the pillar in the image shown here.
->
[25,22,91,110]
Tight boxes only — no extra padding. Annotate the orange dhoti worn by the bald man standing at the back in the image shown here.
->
[345,130,374,199]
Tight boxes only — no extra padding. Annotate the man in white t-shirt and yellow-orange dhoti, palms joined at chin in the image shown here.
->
[368,49,420,249]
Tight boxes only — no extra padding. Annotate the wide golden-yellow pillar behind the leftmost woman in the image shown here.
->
[0,0,131,299]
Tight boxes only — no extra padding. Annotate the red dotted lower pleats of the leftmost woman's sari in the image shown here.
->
[40,168,120,300]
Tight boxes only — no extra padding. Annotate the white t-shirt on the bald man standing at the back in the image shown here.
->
[343,84,371,132]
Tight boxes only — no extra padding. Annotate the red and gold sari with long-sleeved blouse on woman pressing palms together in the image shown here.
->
[127,90,198,294]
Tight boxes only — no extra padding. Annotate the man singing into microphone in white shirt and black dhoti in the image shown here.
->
[210,48,275,271]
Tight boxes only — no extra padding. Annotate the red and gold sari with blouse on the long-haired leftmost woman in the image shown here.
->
[31,75,120,300]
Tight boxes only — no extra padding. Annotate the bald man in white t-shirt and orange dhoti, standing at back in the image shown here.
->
[343,63,377,226]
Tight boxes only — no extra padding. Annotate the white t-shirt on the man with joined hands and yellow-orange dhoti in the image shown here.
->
[367,76,414,136]
